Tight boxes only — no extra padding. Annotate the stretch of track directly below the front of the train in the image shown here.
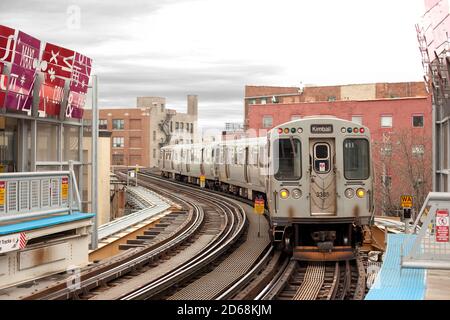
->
[256,255,365,300]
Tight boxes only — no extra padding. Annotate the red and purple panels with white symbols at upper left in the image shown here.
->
[0,25,92,119]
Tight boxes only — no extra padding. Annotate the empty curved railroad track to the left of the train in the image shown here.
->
[24,171,250,300]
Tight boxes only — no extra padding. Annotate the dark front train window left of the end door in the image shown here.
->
[273,138,301,181]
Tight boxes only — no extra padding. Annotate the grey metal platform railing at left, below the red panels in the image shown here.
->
[0,164,81,223]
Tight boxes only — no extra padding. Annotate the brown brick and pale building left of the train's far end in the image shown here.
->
[86,95,198,167]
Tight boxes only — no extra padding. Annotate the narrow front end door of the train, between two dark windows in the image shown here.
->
[309,138,336,216]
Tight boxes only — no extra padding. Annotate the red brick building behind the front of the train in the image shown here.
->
[245,82,432,213]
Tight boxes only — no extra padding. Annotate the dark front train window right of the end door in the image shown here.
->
[344,139,369,180]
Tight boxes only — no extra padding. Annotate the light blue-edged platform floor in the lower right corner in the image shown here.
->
[365,234,450,300]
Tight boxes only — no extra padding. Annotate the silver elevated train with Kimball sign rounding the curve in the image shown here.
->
[159,116,374,261]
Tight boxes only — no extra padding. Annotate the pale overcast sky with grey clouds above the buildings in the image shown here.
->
[0,0,424,128]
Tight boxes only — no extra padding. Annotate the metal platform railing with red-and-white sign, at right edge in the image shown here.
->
[401,192,450,269]
